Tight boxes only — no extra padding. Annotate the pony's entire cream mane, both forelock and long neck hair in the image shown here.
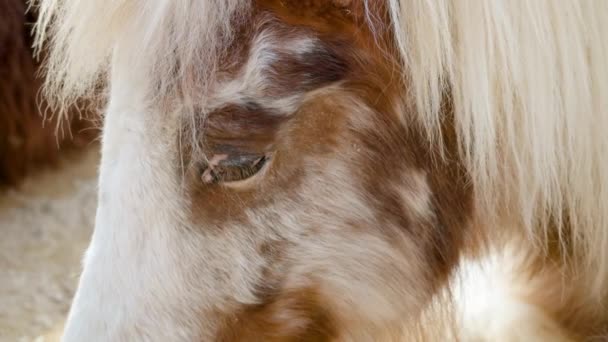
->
[37,0,608,298]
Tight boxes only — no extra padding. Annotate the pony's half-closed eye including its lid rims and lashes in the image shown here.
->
[201,154,269,184]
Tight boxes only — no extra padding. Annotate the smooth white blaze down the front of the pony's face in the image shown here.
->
[64,55,207,341]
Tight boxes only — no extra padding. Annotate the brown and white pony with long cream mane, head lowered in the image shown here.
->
[35,0,608,341]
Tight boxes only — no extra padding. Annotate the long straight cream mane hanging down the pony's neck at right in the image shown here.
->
[389,0,608,289]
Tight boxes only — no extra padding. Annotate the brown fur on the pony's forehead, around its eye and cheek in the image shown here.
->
[191,1,473,341]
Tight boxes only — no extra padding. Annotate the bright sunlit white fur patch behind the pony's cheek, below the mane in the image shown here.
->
[452,245,572,342]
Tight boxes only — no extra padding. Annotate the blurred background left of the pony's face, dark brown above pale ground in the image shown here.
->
[0,0,99,342]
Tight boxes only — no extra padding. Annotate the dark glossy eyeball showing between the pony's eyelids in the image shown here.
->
[204,155,267,183]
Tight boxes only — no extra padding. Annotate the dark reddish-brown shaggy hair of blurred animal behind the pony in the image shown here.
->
[0,0,93,186]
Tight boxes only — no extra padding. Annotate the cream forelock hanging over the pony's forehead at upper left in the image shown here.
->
[34,0,248,110]
